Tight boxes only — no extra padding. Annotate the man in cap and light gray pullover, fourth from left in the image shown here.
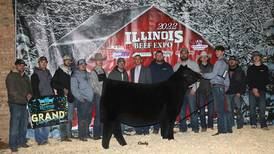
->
[71,59,94,141]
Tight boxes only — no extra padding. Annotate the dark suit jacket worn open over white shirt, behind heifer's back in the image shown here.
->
[130,66,152,83]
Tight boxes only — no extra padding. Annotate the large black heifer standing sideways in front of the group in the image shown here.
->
[100,66,201,148]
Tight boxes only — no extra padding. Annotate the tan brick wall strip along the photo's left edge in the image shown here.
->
[0,0,15,142]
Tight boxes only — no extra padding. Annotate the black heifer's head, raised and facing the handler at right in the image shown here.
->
[170,65,202,86]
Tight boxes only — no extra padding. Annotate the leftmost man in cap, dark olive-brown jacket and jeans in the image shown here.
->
[6,59,32,152]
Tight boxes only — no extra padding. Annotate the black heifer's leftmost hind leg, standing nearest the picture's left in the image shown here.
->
[102,122,113,149]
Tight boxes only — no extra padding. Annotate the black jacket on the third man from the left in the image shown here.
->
[51,67,74,103]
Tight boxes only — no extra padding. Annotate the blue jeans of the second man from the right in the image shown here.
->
[227,94,244,128]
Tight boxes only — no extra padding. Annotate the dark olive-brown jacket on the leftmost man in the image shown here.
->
[6,70,31,105]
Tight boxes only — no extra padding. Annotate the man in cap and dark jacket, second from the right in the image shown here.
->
[226,56,246,129]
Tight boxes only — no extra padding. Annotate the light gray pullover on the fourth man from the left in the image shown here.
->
[70,70,94,102]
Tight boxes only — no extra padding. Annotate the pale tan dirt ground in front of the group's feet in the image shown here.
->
[0,125,274,154]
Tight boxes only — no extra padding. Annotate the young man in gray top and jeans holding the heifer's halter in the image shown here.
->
[203,46,232,136]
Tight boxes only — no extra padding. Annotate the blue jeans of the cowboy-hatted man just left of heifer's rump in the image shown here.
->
[93,94,102,137]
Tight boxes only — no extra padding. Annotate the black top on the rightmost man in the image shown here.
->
[247,64,269,91]
